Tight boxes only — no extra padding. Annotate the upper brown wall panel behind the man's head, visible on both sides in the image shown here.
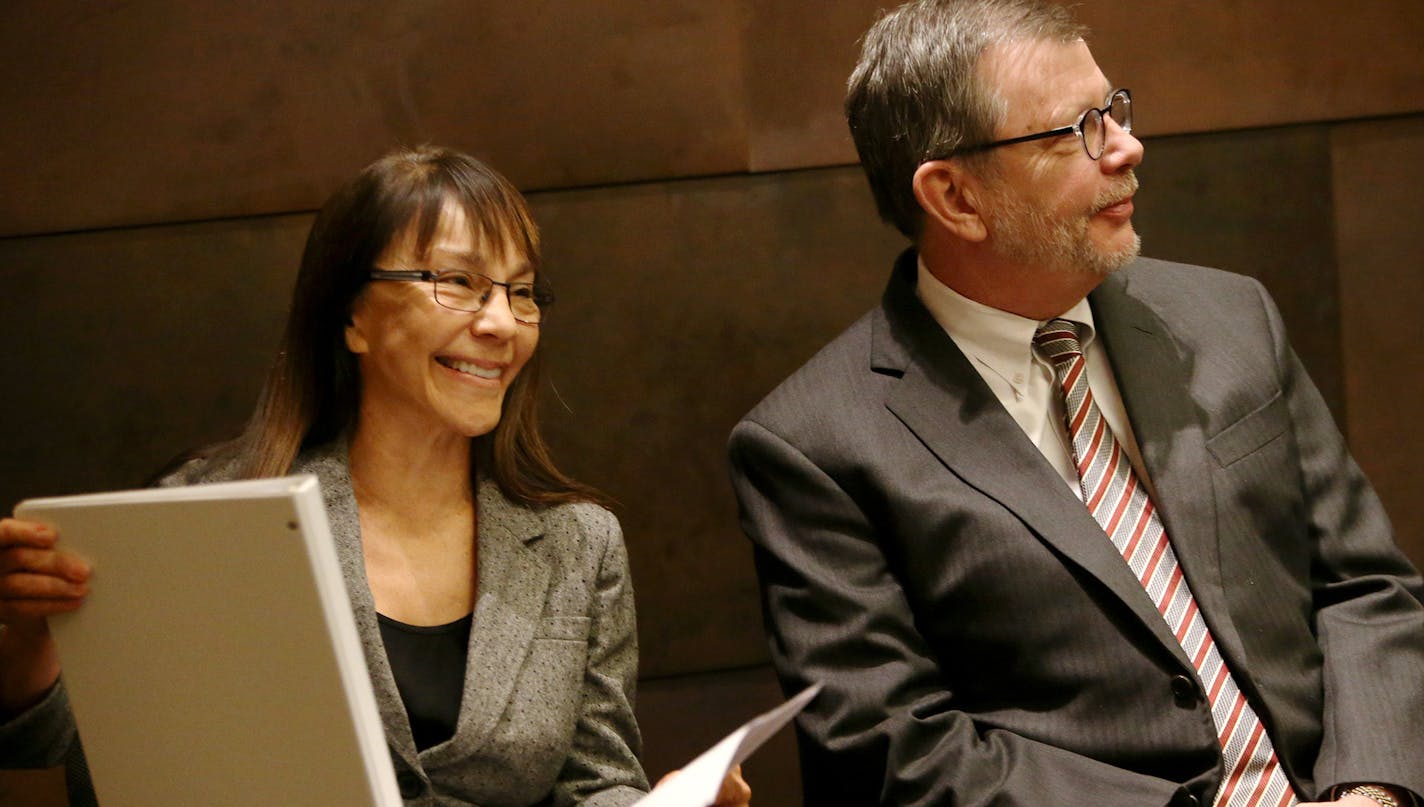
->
[745,0,1424,171]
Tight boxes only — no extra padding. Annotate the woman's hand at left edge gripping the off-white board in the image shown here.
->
[0,518,90,719]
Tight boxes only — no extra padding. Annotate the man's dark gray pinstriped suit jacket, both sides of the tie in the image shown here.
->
[731,252,1424,807]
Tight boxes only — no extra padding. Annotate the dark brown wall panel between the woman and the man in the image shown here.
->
[534,168,899,675]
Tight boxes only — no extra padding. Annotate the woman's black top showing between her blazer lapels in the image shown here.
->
[376,613,474,751]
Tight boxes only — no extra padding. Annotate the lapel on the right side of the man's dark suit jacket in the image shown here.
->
[1089,269,1245,668]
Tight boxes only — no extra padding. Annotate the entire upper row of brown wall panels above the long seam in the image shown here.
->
[0,0,1424,236]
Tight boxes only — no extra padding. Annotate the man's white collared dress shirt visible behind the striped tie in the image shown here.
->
[914,260,1155,498]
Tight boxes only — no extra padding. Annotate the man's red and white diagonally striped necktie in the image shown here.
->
[1034,319,1297,807]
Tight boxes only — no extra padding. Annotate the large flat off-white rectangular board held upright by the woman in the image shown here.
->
[16,475,402,807]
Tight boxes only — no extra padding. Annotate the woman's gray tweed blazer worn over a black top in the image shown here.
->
[0,441,648,807]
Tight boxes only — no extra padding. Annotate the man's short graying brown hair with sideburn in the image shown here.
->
[846,0,1087,239]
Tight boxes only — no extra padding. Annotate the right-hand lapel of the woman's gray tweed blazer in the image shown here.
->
[454,480,551,753]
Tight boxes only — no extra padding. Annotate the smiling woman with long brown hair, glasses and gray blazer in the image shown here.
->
[0,148,750,804]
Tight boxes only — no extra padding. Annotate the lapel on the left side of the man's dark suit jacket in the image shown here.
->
[871,252,1190,668]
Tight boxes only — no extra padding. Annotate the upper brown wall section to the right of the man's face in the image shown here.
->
[1079,0,1424,135]
